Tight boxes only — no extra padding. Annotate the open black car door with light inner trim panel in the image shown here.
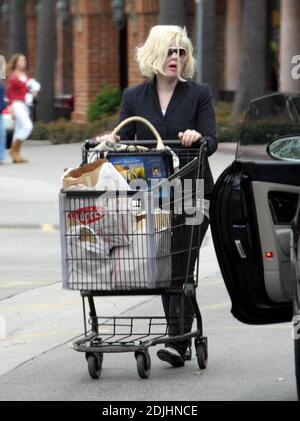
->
[210,161,300,324]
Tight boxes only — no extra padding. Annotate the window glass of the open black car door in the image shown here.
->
[236,93,300,161]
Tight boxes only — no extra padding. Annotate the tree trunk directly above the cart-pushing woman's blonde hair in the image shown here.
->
[159,0,187,26]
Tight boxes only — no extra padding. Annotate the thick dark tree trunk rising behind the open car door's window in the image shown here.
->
[233,0,267,116]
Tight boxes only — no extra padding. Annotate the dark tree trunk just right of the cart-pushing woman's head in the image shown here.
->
[194,0,219,100]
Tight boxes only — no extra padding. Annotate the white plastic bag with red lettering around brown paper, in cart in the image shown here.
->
[63,160,132,248]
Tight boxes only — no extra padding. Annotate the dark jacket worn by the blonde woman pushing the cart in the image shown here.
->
[119,78,218,197]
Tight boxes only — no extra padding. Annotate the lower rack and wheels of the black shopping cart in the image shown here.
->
[73,304,208,379]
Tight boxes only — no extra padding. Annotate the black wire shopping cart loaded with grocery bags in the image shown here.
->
[60,116,208,379]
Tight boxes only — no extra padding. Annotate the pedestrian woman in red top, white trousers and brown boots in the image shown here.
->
[6,54,40,163]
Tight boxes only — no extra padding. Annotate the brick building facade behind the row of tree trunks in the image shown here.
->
[0,0,300,122]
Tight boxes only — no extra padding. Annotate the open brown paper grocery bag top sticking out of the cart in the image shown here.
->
[63,159,107,190]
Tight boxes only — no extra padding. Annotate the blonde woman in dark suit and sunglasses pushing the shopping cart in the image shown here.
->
[100,25,217,367]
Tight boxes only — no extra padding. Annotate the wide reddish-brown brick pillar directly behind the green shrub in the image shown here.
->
[72,0,120,121]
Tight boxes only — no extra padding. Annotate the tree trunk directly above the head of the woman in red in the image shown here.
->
[9,0,27,55]
